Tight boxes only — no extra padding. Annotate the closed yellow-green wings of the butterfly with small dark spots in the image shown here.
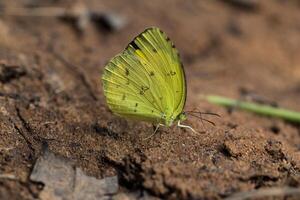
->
[102,28,186,124]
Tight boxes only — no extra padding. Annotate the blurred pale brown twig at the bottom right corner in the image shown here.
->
[225,187,300,200]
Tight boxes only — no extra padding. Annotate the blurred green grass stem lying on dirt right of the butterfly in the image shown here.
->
[204,95,300,123]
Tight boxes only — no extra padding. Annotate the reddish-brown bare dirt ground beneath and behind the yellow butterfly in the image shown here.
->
[0,0,300,199]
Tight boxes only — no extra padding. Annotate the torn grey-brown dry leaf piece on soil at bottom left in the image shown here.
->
[30,150,119,200]
